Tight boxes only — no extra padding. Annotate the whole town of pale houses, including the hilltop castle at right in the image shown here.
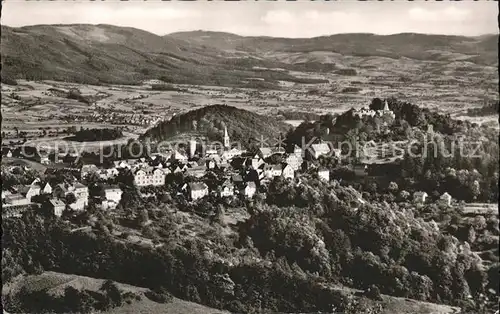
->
[2,101,460,217]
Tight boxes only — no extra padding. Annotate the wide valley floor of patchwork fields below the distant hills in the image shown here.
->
[2,49,498,144]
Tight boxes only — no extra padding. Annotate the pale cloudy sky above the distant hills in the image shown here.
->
[1,0,498,37]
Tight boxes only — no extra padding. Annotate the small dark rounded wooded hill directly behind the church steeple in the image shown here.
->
[143,105,292,145]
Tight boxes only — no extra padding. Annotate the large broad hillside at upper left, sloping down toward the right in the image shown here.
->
[1,24,320,88]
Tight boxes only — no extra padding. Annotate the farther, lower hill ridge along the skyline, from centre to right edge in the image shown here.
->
[169,31,498,65]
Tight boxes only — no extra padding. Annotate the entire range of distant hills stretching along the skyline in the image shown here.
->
[1,24,498,89]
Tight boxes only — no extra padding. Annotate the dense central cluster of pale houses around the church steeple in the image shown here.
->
[81,129,338,200]
